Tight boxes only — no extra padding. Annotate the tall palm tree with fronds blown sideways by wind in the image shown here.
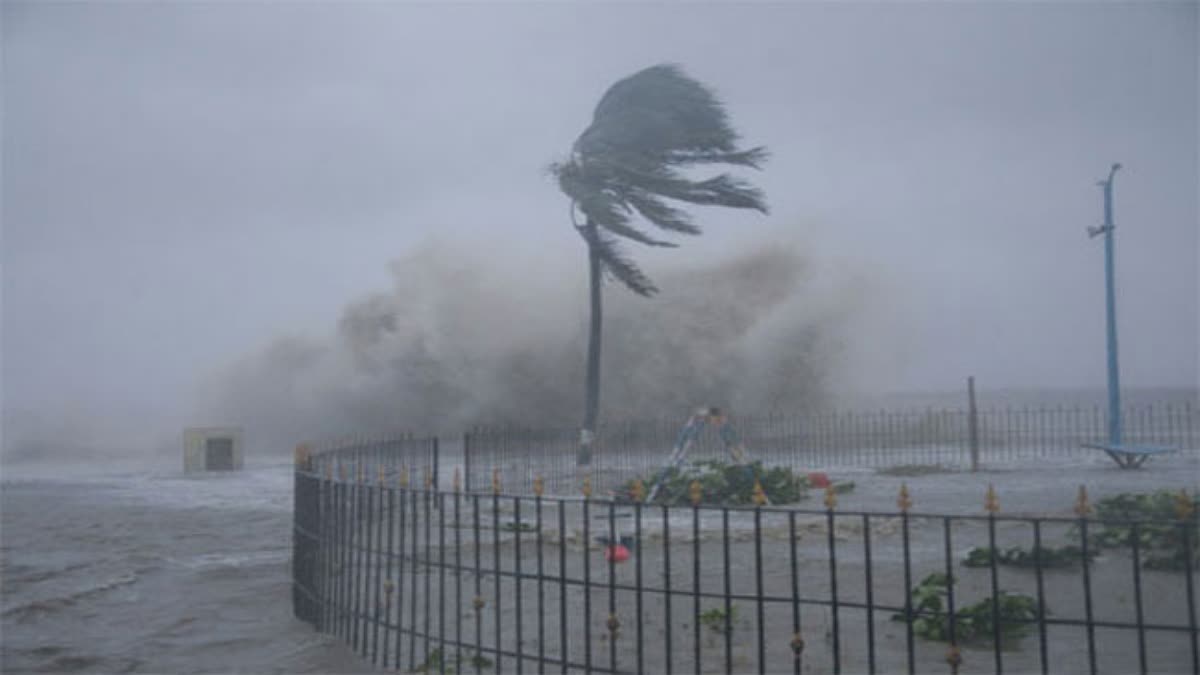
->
[552,65,767,466]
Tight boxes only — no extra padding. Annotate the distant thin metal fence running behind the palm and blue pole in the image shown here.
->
[462,402,1200,492]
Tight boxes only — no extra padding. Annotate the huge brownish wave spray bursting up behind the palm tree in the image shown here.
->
[194,230,884,450]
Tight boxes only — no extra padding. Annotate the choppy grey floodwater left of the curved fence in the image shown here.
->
[0,464,367,673]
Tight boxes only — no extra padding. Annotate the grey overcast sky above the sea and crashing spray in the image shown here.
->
[2,1,1200,451]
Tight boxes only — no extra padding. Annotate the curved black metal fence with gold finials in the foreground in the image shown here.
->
[293,440,1200,673]
